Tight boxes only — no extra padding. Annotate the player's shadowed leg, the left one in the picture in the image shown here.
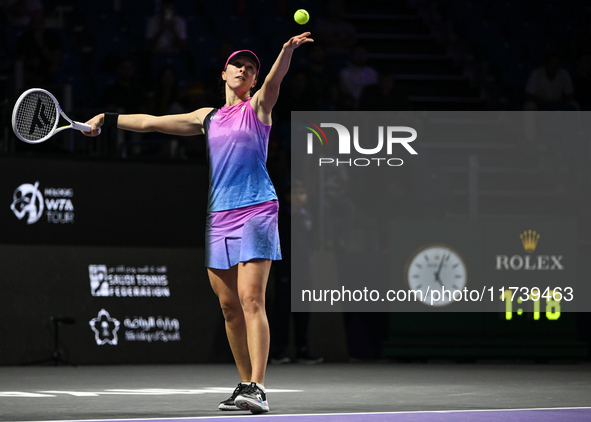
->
[207,265,252,382]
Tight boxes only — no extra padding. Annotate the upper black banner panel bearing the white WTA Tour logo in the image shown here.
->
[0,158,208,247]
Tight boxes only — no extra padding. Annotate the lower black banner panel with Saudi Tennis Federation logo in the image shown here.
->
[0,245,227,364]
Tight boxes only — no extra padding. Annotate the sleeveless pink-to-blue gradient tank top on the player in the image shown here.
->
[205,98,277,212]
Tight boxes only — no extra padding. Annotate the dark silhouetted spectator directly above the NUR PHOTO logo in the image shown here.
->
[358,72,411,111]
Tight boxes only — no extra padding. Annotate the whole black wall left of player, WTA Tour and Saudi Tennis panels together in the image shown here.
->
[0,159,221,364]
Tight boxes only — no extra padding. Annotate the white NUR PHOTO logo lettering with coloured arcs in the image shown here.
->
[303,121,418,167]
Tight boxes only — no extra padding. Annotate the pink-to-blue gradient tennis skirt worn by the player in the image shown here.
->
[205,201,281,270]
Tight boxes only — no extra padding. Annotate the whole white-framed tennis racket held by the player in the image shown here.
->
[12,88,100,144]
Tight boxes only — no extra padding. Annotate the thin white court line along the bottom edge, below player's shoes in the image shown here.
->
[21,406,591,422]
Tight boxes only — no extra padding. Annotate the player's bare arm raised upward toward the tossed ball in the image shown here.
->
[251,32,314,124]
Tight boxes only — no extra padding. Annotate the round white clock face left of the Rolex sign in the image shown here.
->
[406,245,468,306]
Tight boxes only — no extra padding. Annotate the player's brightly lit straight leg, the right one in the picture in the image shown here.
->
[238,259,272,385]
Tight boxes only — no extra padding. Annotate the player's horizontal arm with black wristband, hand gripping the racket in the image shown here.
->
[82,108,212,136]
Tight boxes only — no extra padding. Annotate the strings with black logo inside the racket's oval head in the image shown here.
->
[16,92,57,141]
